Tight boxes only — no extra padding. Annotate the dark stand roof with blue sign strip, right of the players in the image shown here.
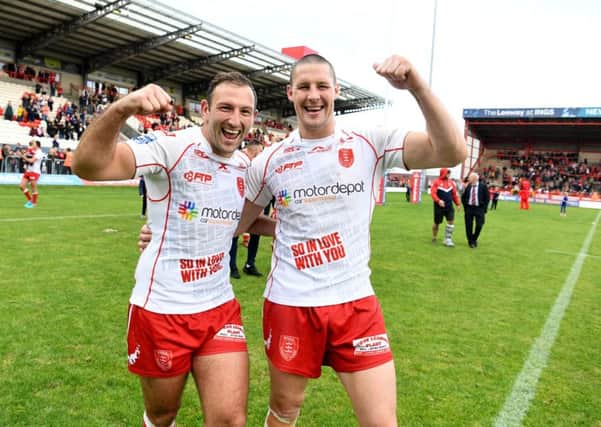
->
[463,107,601,151]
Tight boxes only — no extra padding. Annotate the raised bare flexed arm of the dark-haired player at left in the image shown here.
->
[72,84,171,181]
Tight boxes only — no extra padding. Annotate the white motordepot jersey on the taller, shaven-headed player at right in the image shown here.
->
[246,129,406,306]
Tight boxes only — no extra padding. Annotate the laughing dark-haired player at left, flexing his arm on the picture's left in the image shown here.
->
[73,72,273,427]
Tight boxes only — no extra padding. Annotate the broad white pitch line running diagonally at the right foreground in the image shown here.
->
[494,212,601,427]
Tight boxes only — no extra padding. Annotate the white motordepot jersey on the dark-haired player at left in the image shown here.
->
[127,127,250,314]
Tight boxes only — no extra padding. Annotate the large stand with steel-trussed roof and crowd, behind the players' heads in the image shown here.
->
[0,0,385,177]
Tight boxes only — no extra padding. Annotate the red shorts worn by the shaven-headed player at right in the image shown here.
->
[263,296,392,378]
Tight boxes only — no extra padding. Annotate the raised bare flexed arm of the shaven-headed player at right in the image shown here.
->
[373,55,467,169]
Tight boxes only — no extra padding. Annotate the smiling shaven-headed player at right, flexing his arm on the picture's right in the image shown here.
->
[240,54,466,427]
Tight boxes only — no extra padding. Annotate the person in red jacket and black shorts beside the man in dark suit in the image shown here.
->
[430,168,461,247]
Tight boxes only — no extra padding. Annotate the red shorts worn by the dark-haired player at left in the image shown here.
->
[127,299,247,377]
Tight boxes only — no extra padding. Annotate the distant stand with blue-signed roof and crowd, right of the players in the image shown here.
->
[463,108,601,198]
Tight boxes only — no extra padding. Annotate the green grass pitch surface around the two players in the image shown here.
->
[0,186,601,427]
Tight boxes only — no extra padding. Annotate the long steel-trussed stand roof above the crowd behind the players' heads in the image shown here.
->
[0,0,385,116]
